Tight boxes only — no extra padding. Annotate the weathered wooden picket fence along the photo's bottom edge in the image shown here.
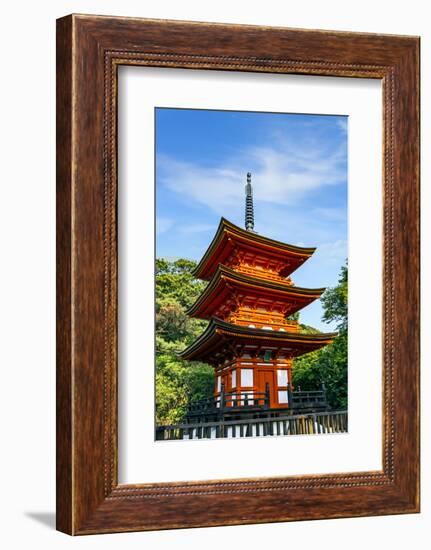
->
[156,411,347,441]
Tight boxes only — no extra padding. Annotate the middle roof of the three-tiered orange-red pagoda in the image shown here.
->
[187,265,325,319]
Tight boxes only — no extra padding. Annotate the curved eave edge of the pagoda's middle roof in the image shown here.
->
[187,265,325,319]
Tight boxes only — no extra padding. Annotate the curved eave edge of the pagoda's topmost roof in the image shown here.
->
[192,218,316,279]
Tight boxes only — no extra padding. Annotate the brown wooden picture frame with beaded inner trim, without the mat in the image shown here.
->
[57,15,419,534]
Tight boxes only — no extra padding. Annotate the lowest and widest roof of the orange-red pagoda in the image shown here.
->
[179,319,337,364]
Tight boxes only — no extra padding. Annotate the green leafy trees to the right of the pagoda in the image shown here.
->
[292,266,348,409]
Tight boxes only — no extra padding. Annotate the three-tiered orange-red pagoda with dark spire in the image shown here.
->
[181,173,336,420]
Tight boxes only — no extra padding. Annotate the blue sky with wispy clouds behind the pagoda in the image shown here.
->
[156,108,347,330]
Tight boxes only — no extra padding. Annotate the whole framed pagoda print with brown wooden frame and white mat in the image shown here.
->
[57,15,419,534]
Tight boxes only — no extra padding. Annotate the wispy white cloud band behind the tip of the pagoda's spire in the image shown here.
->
[157,136,346,216]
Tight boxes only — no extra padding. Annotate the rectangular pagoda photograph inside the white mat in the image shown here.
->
[155,107,348,441]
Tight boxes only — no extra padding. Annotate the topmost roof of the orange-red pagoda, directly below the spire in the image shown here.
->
[193,218,316,280]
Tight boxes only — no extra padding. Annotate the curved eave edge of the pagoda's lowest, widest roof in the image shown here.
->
[179,319,338,362]
